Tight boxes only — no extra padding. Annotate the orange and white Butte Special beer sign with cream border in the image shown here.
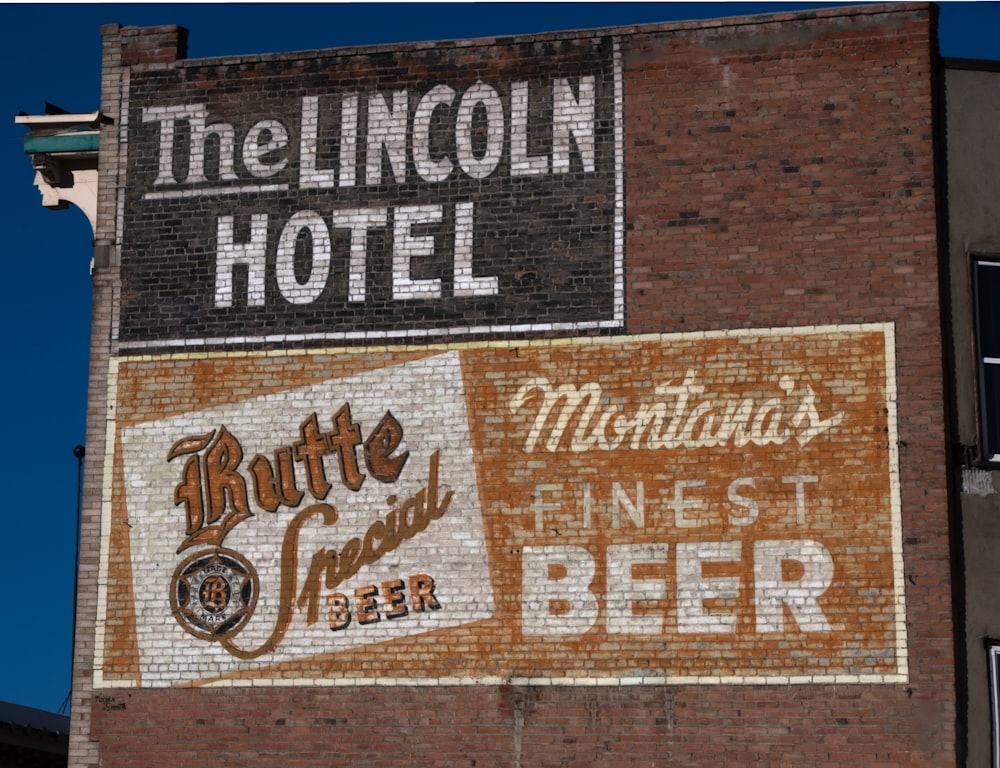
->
[97,325,906,686]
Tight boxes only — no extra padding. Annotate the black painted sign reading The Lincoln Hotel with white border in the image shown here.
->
[119,38,624,351]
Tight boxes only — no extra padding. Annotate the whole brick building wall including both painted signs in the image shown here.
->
[71,5,955,766]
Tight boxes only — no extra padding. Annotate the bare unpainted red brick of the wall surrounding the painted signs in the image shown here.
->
[71,5,955,766]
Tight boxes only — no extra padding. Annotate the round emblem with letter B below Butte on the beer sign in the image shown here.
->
[170,549,259,640]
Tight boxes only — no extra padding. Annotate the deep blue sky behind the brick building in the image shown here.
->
[0,2,1000,711]
